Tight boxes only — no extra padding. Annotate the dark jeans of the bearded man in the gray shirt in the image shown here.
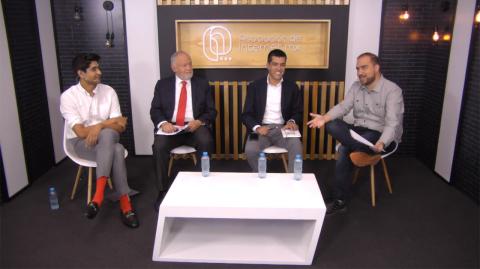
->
[325,119,395,201]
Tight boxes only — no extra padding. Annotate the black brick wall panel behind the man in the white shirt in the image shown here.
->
[51,0,134,154]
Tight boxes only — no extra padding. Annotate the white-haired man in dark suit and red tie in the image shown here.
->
[150,51,217,210]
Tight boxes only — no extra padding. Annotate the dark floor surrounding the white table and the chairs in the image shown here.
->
[0,157,479,269]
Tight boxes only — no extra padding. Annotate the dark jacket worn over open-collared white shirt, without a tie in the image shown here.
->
[242,77,303,132]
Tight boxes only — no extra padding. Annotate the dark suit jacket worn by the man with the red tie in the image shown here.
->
[150,76,217,132]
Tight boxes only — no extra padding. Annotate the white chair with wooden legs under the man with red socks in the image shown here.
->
[63,122,123,204]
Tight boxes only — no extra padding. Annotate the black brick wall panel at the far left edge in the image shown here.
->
[2,0,54,182]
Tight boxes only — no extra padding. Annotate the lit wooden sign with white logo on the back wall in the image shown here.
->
[175,20,330,69]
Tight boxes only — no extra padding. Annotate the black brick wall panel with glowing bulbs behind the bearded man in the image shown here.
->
[379,0,456,161]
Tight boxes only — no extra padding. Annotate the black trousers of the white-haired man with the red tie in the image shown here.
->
[152,126,213,192]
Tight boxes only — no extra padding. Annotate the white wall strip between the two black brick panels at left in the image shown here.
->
[35,0,66,163]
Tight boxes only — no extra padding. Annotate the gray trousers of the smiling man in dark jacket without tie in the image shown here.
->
[245,124,302,173]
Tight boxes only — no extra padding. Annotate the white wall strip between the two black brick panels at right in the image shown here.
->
[435,0,475,182]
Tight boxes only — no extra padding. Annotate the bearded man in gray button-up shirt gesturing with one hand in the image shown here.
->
[307,52,404,215]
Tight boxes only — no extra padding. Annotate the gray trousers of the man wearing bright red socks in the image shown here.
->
[68,128,130,195]
